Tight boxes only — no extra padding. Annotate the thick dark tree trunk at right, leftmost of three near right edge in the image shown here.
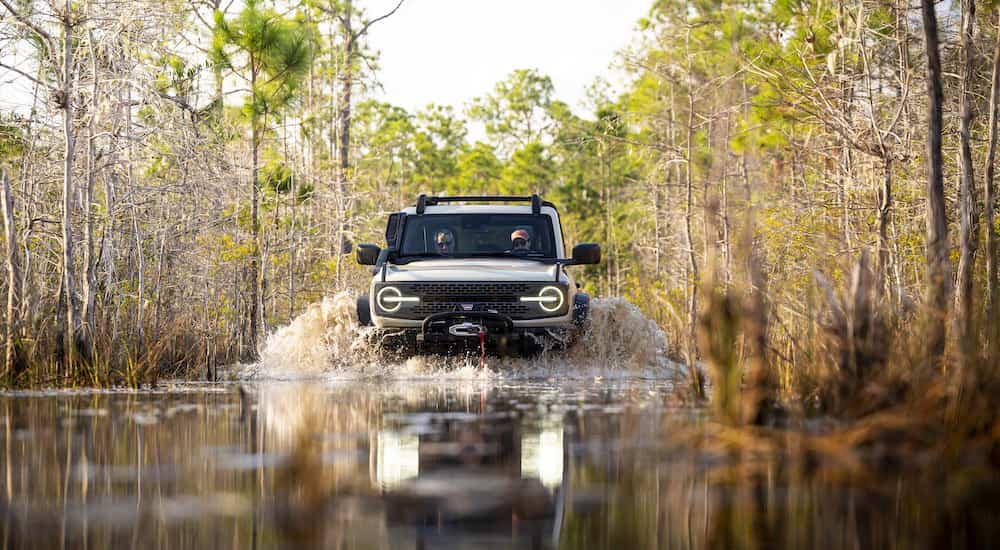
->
[920,0,951,364]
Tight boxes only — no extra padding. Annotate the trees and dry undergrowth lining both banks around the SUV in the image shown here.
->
[0,0,1000,484]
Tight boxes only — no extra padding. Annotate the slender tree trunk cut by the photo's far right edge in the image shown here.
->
[983,10,1000,346]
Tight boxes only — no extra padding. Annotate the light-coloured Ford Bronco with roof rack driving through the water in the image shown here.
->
[357,195,601,354]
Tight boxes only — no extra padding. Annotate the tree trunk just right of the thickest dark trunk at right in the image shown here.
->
[955,0,978,351]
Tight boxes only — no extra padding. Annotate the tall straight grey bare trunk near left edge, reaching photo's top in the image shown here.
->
[61,0,80,375]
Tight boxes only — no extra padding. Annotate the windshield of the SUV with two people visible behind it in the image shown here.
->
[399,214,556,258]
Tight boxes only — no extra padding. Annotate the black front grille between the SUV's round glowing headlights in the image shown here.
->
[384,281,554,320]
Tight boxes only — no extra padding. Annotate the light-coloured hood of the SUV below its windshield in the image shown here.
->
[385,258,556,283]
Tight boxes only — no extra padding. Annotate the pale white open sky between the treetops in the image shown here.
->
[364,0,653,115]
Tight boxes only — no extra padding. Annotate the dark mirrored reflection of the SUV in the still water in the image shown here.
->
[377,392,562,548]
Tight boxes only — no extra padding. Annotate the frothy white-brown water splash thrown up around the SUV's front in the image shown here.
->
[243,292,684,381]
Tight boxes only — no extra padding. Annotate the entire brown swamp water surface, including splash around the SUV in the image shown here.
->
[0,296,1000,550]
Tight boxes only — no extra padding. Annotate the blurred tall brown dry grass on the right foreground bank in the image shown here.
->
[698,246,1000,471]
